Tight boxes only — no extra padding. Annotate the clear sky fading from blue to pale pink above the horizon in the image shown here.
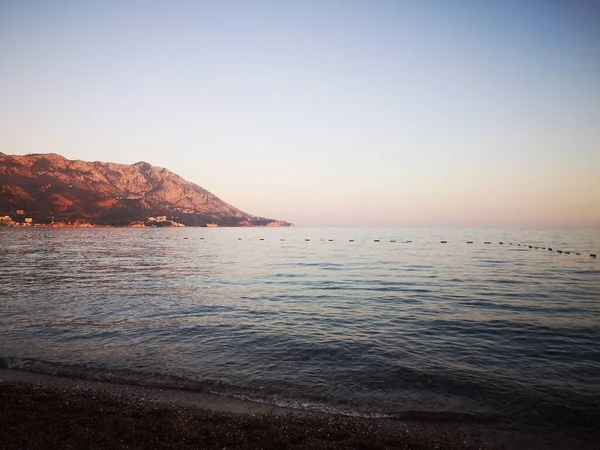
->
[0,0,600,226]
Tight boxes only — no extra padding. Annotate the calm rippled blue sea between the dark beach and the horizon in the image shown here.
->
[0,228,600,427]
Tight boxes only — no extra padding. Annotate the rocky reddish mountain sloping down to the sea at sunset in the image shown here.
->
[0,153,291,226]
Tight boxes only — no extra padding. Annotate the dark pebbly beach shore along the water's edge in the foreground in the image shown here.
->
[0,370,598,450]
